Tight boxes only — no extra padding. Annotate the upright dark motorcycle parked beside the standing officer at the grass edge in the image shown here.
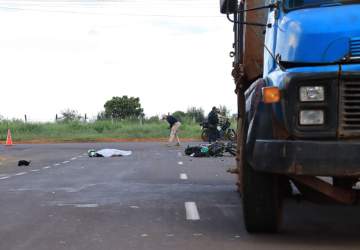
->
[200,119,236,142]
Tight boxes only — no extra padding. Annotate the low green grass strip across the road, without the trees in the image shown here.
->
[0,121,201,142]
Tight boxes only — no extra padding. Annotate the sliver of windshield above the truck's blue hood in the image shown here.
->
[284,0,360,10]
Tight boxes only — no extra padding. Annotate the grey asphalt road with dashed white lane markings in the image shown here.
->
[0,143,360,250]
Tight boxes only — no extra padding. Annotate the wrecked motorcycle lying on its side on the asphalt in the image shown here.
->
[185,142,236,157]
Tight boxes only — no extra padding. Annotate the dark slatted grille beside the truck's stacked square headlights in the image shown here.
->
[339,80,360,137]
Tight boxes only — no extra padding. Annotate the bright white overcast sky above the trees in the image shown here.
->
[0,0,236,121]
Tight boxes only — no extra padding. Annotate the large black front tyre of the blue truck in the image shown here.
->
[242,163,282,233]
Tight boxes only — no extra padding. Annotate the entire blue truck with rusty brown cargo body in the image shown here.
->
[220,0,360,233]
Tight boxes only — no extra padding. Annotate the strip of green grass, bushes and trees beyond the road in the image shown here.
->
[0,96,235,143]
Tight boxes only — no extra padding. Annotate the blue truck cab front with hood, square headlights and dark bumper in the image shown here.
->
[255,0,360,176]
